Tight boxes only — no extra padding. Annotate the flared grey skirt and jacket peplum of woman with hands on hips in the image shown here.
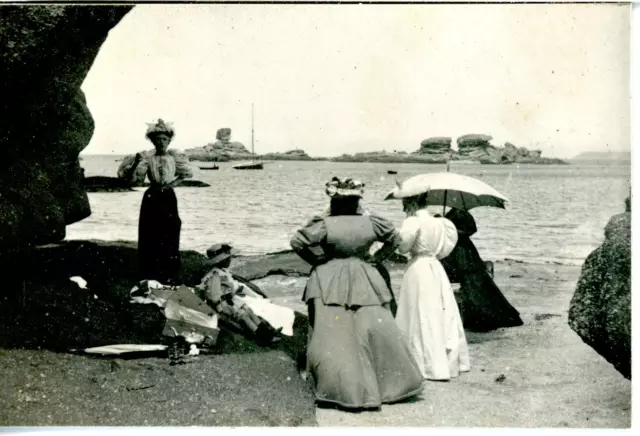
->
[304,258,423,409]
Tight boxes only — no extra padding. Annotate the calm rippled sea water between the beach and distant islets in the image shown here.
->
[67,156,631,264]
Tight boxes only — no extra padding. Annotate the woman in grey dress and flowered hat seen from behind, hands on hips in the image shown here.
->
[291,178,423,409]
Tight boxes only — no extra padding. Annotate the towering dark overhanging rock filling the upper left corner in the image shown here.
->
[0,5,131,252]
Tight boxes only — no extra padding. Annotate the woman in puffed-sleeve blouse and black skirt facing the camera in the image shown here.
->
[122,119,193,283]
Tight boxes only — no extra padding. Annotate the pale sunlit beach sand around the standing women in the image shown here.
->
[256,261,631,428]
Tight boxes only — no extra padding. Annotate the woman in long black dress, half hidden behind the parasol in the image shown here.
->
[442,209,523,332]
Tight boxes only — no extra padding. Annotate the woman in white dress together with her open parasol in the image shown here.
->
[386,172,507,380]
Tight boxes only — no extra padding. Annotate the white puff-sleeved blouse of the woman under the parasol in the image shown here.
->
[398,209,458,259]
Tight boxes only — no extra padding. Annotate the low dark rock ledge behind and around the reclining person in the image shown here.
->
[0,241,308,361]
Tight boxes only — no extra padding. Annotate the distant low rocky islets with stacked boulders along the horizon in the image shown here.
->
[185,128,568,165]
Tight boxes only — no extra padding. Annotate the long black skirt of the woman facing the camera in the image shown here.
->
[138,186,182,283]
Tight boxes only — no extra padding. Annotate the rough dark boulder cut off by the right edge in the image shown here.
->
[569,201,631,379]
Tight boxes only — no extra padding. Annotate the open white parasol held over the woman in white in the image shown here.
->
[385,172,509,210]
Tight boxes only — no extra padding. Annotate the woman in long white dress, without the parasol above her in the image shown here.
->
[396,194,471,381]
